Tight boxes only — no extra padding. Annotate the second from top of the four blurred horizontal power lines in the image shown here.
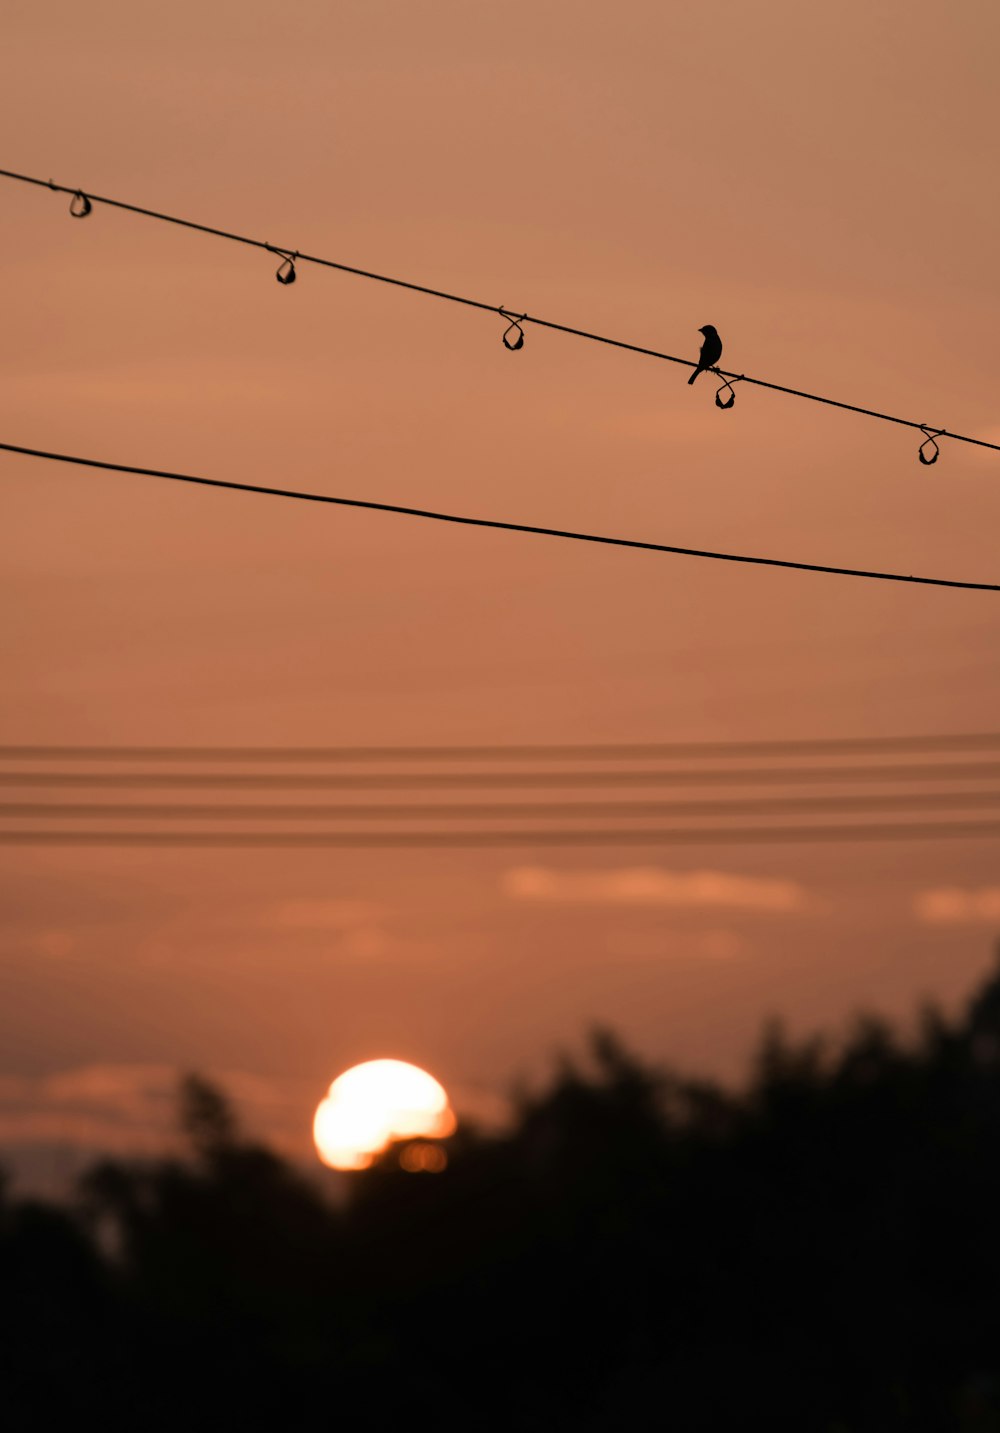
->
[0,761,1000,791]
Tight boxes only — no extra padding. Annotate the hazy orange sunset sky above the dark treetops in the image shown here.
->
[0,0,1000,1186]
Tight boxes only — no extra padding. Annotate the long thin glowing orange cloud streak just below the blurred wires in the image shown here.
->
[501,866,807,913]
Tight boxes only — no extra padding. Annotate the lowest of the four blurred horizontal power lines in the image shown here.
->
[0,821,1000,850]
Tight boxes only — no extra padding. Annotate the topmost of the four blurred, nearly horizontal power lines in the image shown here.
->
[0,732,1000,764]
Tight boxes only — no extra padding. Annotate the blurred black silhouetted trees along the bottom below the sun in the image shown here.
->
[0,957,1000,1433]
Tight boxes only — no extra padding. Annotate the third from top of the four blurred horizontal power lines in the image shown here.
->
[0,791,1000,821]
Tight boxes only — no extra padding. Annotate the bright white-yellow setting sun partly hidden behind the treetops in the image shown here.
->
[312,1060,456,1169]
